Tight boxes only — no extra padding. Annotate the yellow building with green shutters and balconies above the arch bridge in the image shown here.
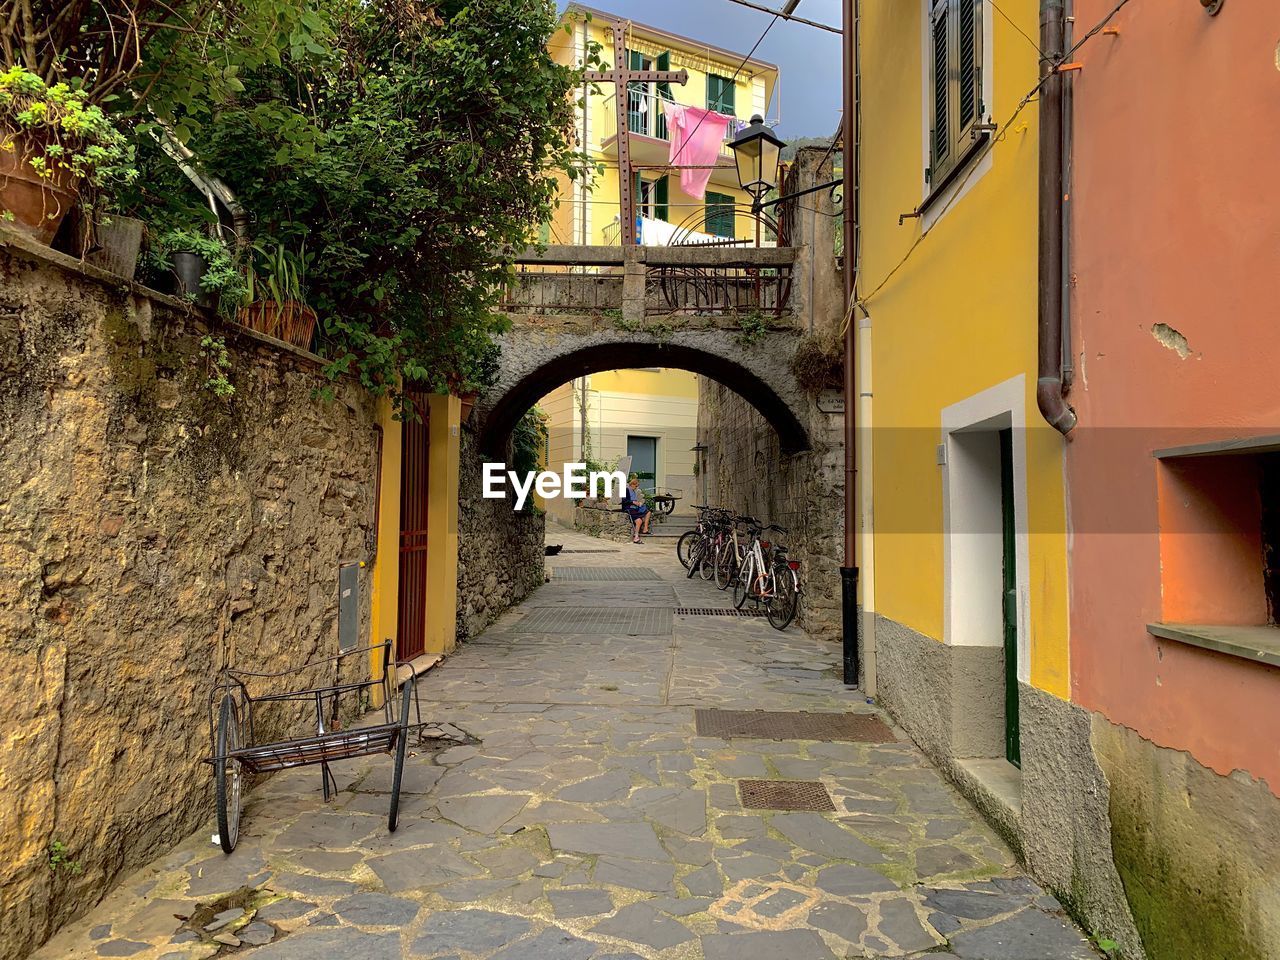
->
[545,3,778,246]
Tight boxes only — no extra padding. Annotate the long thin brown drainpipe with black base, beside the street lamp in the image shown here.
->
[840,0,861,686]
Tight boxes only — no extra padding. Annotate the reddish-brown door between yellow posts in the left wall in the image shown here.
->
[396,394,429,660]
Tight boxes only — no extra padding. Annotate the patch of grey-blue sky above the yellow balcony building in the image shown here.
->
[557,0,841,141]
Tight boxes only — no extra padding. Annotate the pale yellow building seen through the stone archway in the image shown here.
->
[539,367,698,526]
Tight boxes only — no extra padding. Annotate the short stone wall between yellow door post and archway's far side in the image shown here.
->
[458,429,547,643]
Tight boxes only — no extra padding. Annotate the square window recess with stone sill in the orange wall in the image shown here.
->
[1147,436,1280,666]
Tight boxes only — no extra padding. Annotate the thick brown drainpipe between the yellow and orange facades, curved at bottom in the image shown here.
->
[1036,0,1075,435]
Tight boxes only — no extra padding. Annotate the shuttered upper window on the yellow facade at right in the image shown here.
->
[925,0,989,195]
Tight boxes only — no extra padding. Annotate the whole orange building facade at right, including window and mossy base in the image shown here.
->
[1066,0,1280,960]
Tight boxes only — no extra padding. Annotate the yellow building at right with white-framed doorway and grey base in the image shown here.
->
[854,0,1070,842]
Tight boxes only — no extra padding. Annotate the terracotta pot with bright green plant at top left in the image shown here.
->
[0,65,137,243]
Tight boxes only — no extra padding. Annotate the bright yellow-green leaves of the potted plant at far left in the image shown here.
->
[0,65,138,215]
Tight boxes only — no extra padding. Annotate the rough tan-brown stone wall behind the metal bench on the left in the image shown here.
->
[0,238,378,960]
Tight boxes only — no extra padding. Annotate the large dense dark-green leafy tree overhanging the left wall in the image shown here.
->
[120,0,599,409]
